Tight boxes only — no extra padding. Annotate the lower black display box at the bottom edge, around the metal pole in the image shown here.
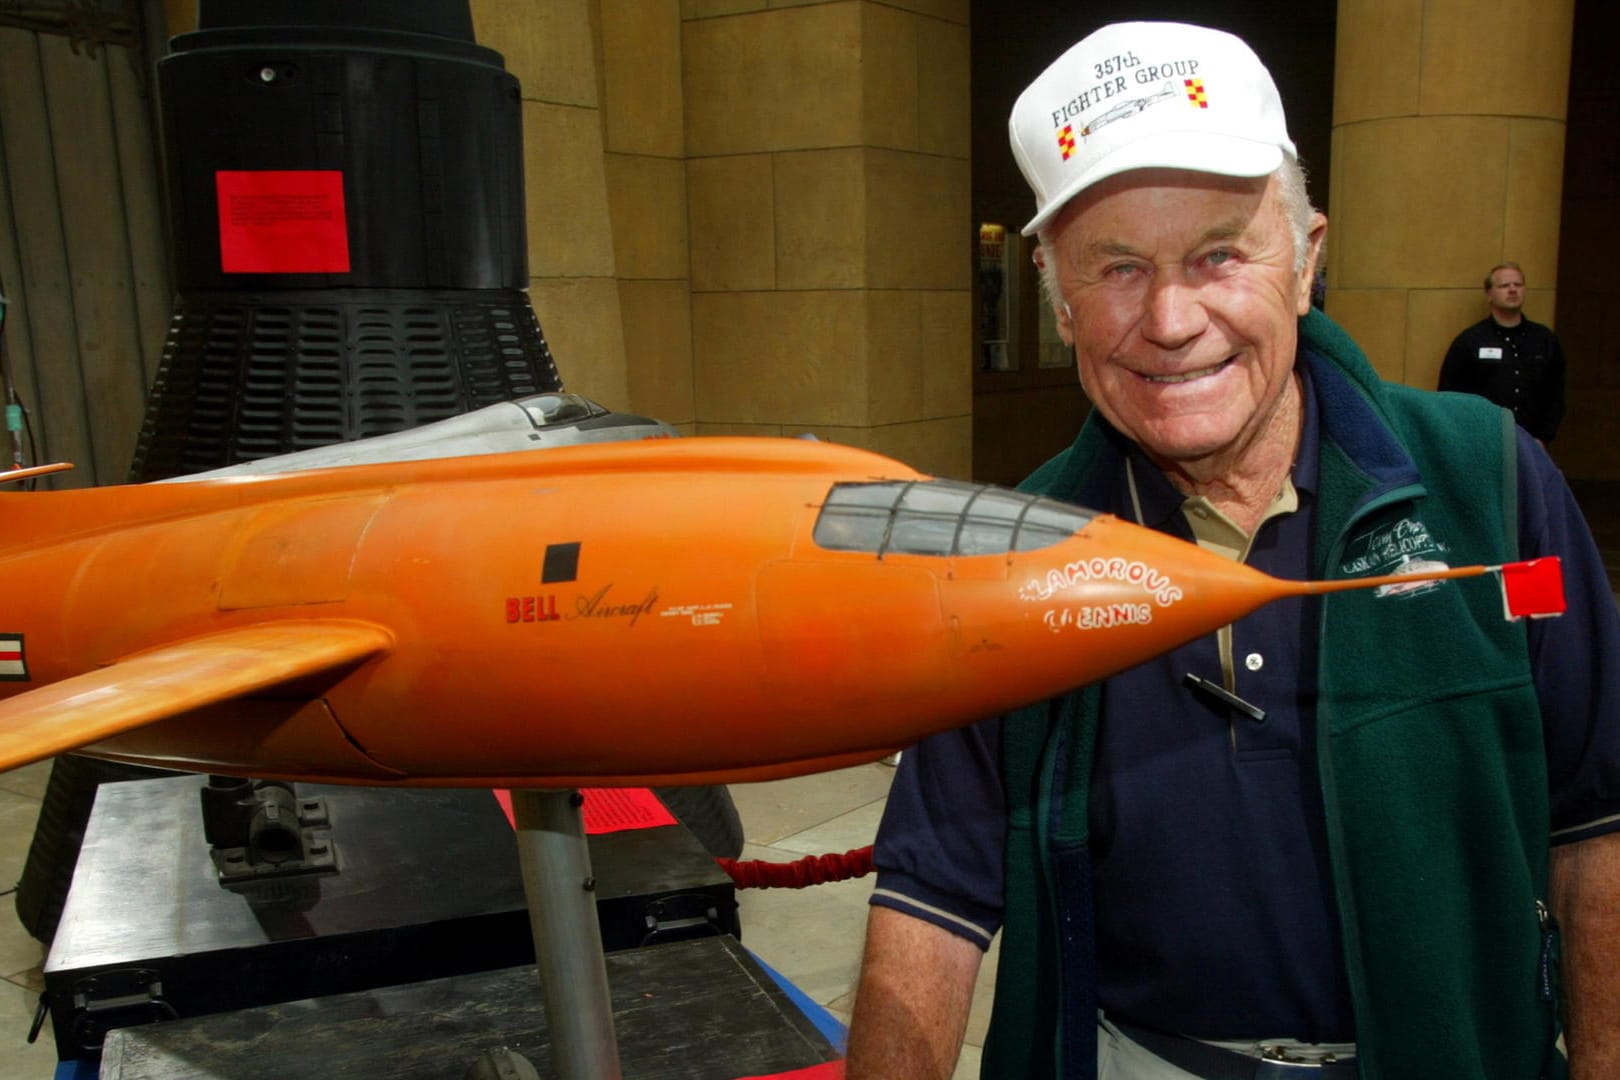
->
[100,936,838,1080]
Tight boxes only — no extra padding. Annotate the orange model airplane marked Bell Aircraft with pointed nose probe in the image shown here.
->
[0,427,1562,787]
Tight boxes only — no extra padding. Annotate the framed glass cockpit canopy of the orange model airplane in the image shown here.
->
[815,479,1097,557]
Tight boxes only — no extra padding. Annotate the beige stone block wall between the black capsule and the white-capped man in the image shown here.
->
[473,0,974,476]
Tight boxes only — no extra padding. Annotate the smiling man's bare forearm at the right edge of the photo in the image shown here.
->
[1552,832,1620,1080]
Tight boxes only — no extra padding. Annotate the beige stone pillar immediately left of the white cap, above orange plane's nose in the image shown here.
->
[682,0,975,478]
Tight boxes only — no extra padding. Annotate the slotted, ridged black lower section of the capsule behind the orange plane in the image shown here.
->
[131,290,562,481]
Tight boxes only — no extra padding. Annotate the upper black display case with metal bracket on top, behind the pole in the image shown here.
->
[44,776,739,1075]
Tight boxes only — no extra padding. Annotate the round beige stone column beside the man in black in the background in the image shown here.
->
[1327,0,1573,387]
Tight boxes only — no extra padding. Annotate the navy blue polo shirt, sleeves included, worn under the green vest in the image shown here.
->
[872,366,1620,1043]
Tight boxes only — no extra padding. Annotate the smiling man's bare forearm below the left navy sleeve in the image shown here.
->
[844,907,983,1080]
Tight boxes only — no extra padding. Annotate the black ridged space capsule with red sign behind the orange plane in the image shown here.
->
[131,0,562,481]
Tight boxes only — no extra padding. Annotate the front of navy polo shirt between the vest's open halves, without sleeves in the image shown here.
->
[1090,378,1354,1043]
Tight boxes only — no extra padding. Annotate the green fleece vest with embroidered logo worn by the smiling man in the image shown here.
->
[982,313,1563,1080]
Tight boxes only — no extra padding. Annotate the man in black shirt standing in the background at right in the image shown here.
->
[1440,262,1563,445]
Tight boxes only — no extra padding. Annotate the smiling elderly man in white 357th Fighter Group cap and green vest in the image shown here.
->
[847,23,1620,1080]
